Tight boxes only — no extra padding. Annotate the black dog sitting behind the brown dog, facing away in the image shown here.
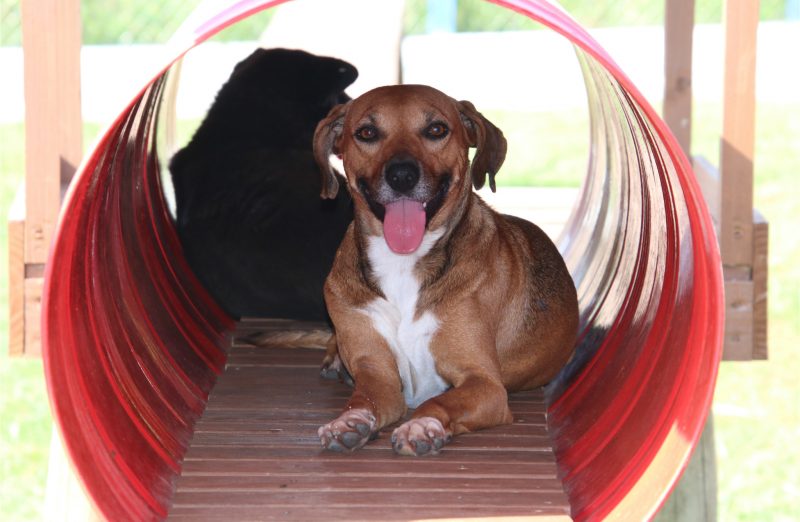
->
[169,49,358,321]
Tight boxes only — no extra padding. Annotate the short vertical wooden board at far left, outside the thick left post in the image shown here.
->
[8,181,25,356]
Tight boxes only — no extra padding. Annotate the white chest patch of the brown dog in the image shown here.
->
[362,232,449,408]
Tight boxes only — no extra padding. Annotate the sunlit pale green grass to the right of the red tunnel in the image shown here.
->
[695,105,800,522]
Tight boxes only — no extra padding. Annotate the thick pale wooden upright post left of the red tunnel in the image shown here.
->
[20,0,82,263]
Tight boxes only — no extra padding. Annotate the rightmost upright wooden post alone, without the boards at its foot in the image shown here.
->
[720,0,759,267]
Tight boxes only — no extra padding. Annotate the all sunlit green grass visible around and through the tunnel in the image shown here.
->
[0,99,800,522]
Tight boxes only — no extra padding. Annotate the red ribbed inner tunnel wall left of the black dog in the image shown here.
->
[43,75,233,520]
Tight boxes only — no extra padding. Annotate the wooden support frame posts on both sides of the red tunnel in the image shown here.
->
[8,0,768,360]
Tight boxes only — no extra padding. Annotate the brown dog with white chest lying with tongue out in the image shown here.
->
[314,85,578,455]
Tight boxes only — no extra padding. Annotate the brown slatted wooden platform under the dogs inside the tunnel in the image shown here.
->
[170,318,569,521]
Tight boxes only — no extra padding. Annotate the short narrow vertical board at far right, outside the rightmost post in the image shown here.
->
[753,210,769,360]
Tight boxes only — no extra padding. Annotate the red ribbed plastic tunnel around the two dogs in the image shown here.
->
[43,0,723,520]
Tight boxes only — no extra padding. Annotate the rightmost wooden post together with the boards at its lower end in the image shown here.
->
[719,0,769,360]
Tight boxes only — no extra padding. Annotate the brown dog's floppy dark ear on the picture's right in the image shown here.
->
[458,101,508,192]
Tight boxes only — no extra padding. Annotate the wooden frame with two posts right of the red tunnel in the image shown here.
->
[663,0,769,361]
